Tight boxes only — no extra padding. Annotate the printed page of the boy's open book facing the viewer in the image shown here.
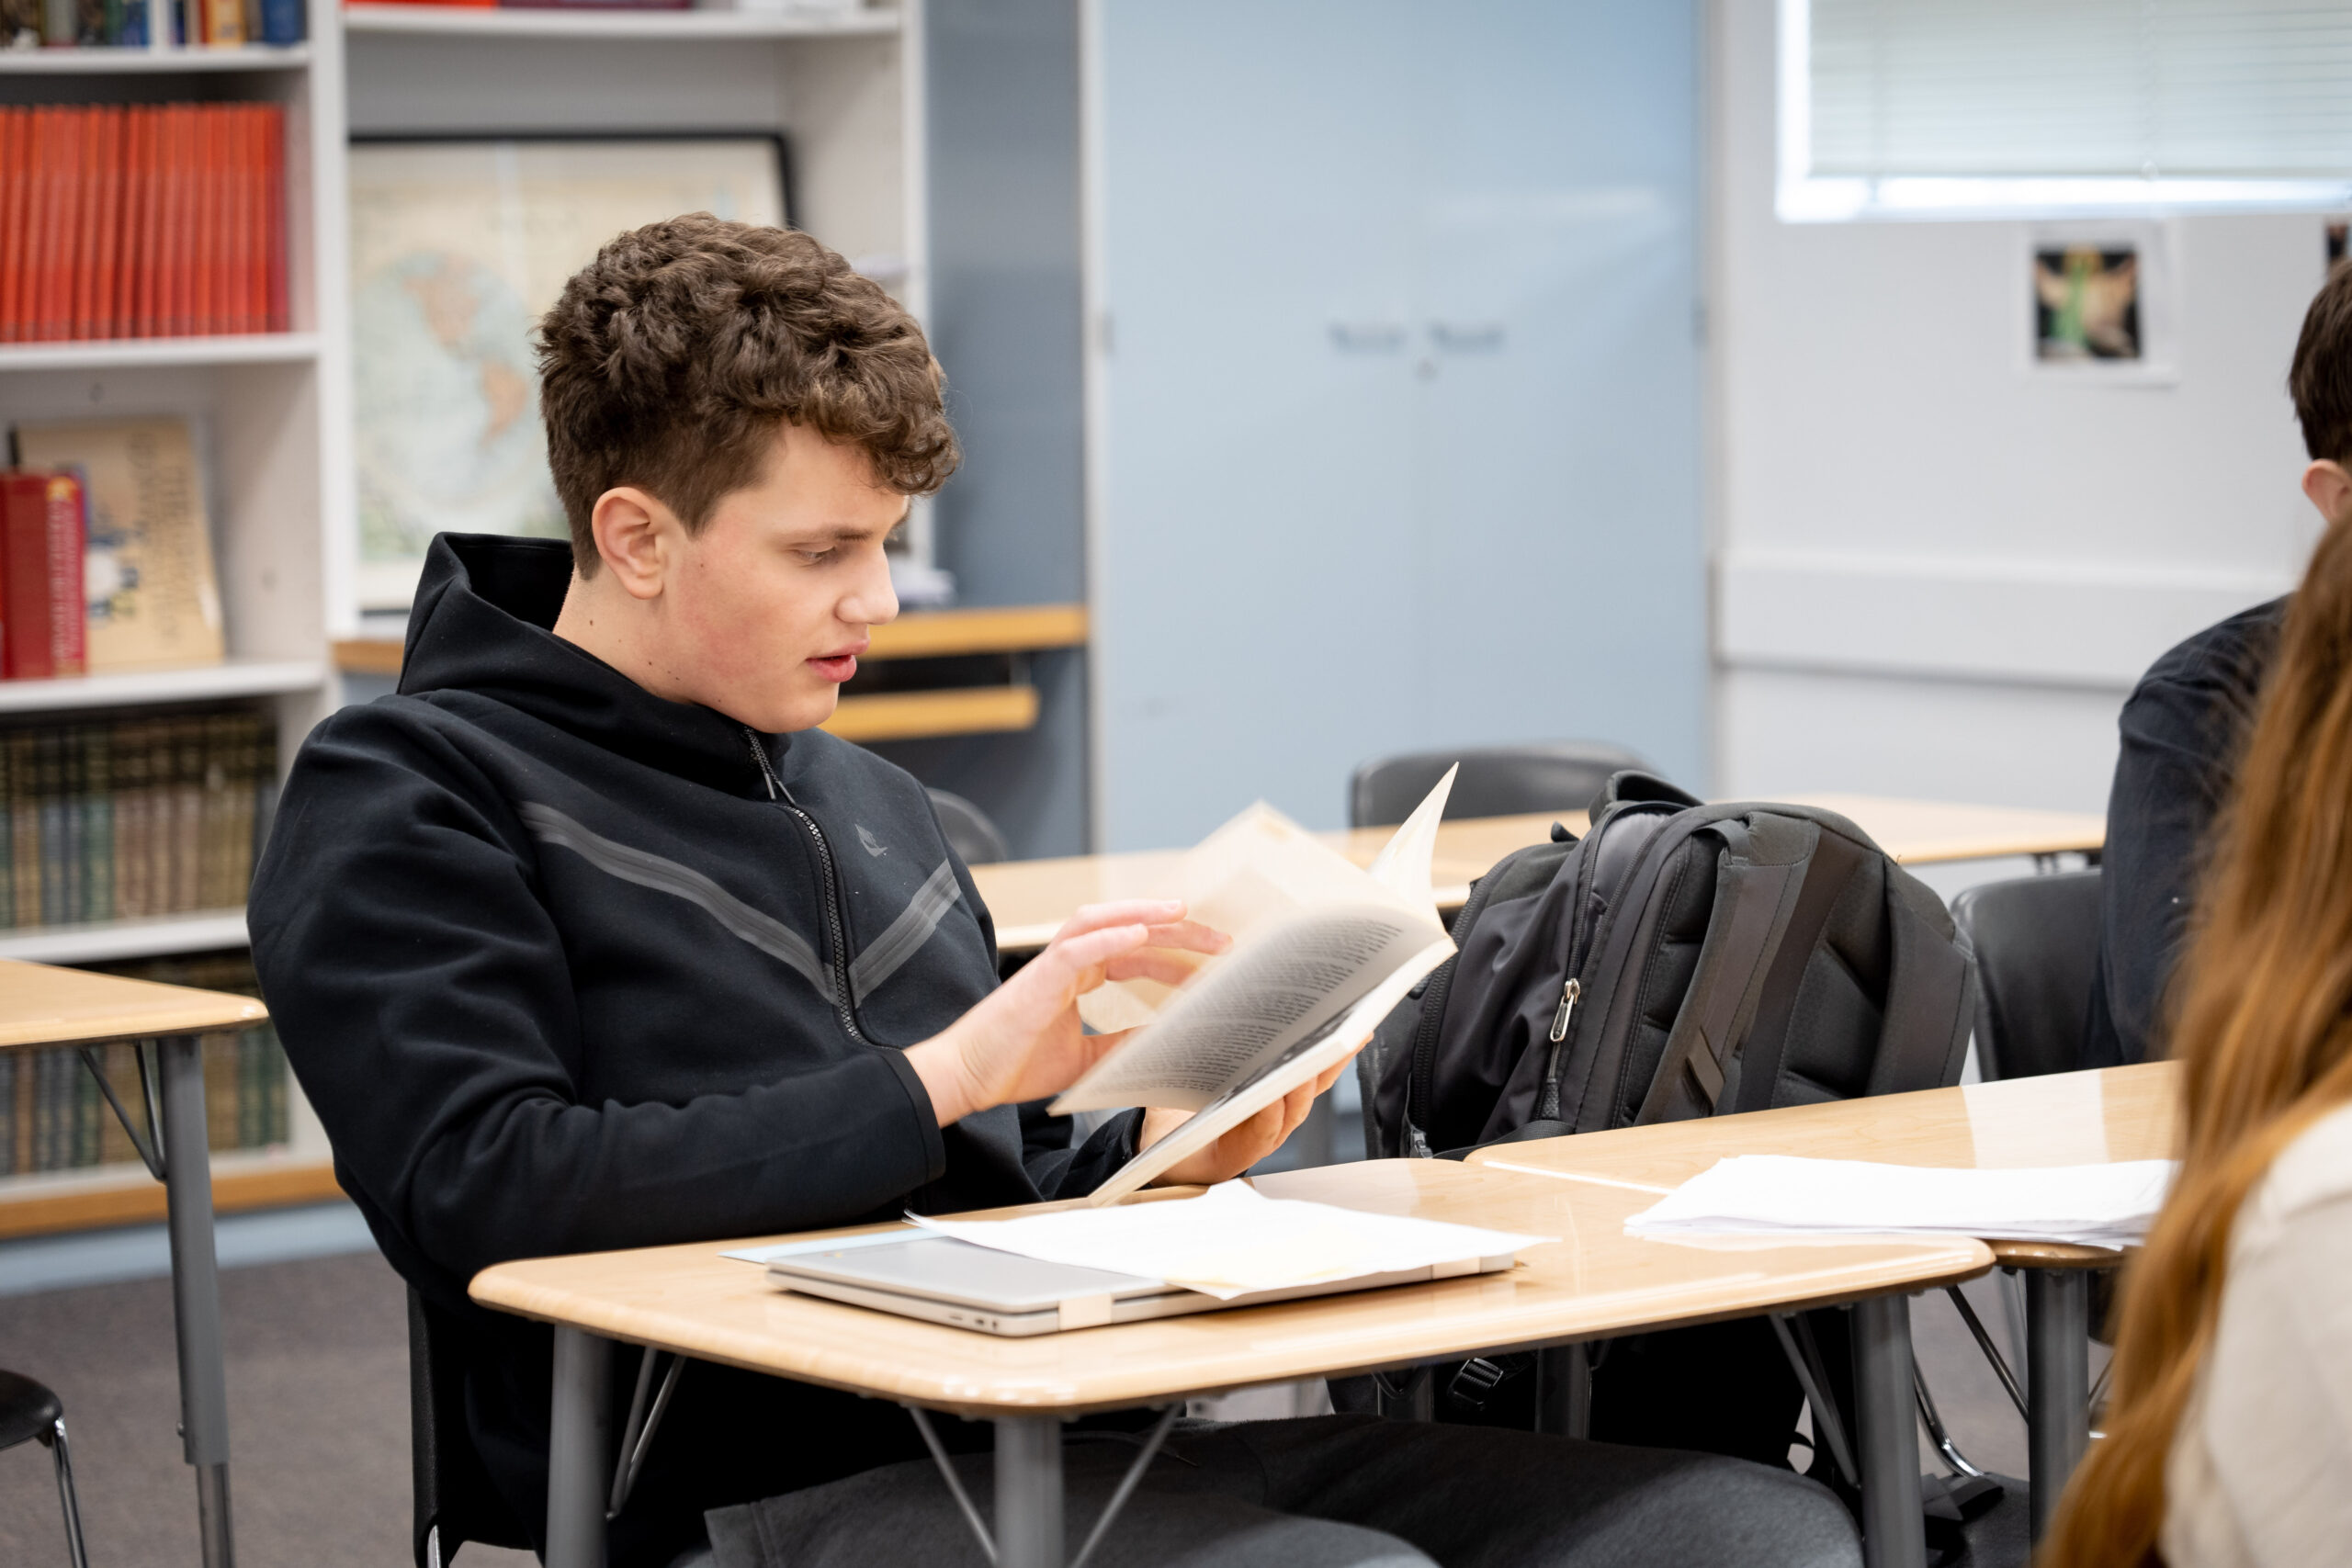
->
[1054,905,1444,1114]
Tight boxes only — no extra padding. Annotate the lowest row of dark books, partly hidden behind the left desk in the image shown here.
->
[0,952,291,1176]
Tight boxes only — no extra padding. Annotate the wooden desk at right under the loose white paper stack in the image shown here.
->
[1470,1063,2180,1535]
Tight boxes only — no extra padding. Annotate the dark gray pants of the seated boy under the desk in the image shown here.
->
[708,1416,1863,1568]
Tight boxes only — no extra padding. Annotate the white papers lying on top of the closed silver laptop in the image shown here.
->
[908,1182,1553,1300]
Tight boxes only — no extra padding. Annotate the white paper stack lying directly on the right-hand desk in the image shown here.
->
[1625,1155,2178,1248]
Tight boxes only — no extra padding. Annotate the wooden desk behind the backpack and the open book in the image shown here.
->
[971,795,2108,952]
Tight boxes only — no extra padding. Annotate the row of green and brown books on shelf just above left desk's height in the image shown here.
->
[0,707,277,926]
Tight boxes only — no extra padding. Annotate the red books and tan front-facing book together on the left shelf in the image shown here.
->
[0,419,226,680]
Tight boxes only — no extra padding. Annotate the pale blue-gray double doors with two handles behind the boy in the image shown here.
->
[1093,0,1705,849]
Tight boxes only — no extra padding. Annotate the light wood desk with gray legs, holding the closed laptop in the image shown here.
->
[473,1161,1992,1568]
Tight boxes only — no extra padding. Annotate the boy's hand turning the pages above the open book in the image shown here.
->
[906,900,1232,1138]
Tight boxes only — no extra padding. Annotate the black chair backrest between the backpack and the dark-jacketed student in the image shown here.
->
[1952,870,2098,1079]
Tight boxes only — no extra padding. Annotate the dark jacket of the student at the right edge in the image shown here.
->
[2082,600,2286,1067]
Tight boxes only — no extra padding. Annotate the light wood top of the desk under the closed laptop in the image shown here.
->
[473,1159,1992,1417]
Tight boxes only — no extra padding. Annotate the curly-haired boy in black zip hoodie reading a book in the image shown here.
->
[252,214,1853,1568]
